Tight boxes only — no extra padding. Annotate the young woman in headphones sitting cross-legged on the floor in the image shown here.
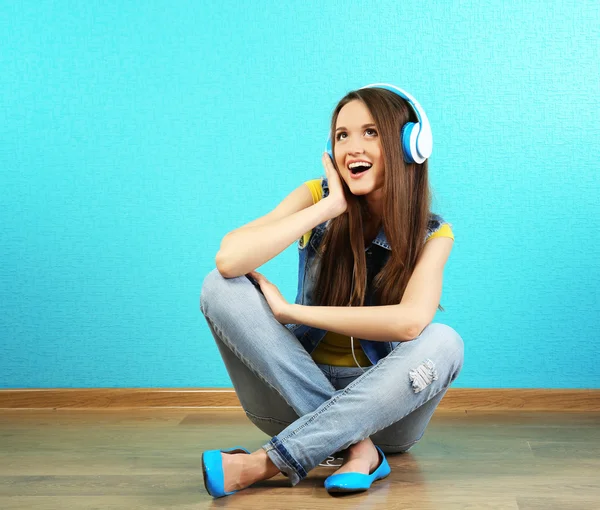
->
[200,84,464,497]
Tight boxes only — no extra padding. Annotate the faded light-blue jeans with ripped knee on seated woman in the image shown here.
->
[200,269,464,485]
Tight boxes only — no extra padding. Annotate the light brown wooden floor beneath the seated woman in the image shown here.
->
[0,409,600,510]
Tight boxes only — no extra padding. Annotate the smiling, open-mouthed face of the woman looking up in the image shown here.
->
[333,100,384,195]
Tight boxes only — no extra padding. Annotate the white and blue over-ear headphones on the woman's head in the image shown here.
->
[327,83,433,163]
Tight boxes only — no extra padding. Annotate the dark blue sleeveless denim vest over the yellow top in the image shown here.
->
[285,178,444,365]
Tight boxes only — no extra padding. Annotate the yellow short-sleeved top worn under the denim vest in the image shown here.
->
[302,179,454,367]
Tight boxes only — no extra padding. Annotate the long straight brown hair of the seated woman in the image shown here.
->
[315,88,443,310]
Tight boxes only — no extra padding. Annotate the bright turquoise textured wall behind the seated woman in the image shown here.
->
[0,0,600,388]
